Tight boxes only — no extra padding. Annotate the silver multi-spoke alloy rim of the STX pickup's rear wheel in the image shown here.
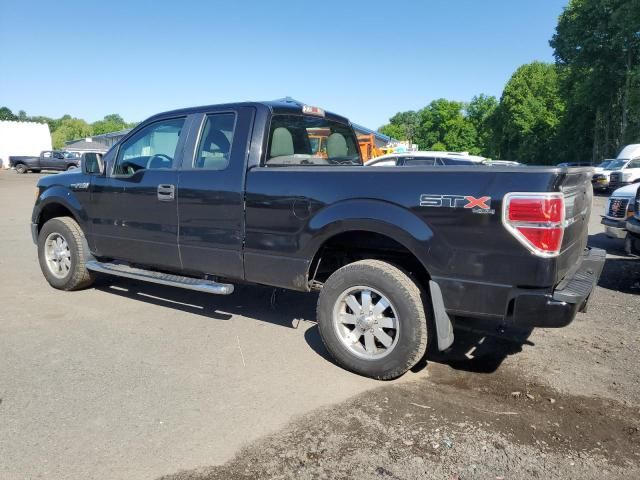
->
[333,286,400,360]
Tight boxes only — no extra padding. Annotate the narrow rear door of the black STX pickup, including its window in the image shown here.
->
[178,107,254,279]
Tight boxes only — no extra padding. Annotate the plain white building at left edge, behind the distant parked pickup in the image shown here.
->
[0,120,51,168]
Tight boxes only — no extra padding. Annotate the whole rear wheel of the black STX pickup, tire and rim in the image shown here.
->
[317,260,428,380]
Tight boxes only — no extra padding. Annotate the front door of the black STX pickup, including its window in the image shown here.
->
[90,116,190,270]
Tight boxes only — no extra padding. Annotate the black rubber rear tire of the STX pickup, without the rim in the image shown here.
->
[317,260,431,380]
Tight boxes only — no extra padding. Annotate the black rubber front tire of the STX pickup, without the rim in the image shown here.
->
[38,217,94,290]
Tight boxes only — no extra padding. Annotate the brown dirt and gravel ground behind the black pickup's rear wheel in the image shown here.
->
[163,193,640,480]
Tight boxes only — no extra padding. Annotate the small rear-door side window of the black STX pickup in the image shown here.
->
[193,113,236,170]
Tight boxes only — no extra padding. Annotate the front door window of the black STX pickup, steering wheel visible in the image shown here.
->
[113,118,185,176]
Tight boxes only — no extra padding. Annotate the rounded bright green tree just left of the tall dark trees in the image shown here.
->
[496,62,564,163]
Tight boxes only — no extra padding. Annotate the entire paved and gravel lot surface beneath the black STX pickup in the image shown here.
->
[0,172,640,480]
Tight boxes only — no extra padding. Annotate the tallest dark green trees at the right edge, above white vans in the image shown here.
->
[550,0,640,161]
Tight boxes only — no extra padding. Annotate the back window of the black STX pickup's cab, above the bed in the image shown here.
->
[266,115,362,167]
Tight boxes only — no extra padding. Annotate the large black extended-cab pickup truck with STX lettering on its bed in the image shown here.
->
[32,102,604,379]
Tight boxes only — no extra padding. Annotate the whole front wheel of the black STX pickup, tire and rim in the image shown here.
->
[38,217,94,290]
